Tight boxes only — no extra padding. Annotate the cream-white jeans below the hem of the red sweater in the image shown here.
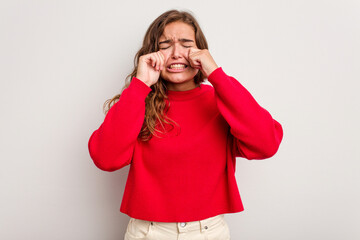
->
[124,214,230,240]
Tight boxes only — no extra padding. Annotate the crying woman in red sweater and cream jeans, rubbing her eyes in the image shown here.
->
[88,10,283,240]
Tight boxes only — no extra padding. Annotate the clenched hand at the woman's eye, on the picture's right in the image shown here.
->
[188,48,218,77]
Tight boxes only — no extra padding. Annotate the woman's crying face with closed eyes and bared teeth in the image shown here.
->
[159,22,199,85]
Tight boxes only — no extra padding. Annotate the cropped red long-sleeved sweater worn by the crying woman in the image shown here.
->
[88,67,283,222]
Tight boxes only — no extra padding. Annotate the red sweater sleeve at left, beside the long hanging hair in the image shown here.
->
[88,77,151,172]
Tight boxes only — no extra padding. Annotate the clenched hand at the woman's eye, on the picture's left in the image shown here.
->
[136,51,164,87]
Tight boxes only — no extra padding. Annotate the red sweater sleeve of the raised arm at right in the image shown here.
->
[208,67,283,160]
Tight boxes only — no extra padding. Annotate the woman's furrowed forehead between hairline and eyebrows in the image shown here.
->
[160,22,195,40]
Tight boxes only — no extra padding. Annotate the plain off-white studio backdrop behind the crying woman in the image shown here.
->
[0,0,360,240]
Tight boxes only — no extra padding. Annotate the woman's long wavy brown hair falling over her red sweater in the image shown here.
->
[104,10,208,141]
